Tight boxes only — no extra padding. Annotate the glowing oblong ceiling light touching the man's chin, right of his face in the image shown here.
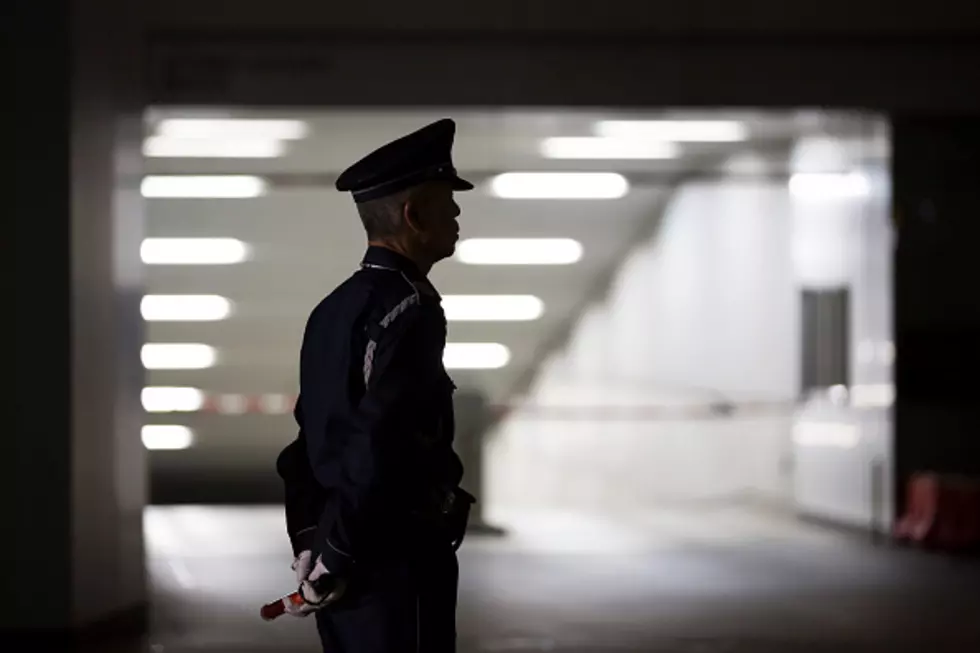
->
[456,238,582,265]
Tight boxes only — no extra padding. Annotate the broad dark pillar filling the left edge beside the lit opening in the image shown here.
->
[0,0,147,650]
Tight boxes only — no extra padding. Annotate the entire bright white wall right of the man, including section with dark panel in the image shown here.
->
[486,132,894,528]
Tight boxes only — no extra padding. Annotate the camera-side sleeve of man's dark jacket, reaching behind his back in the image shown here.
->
[315,310,441,575]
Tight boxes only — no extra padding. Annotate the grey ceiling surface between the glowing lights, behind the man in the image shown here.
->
[146,108,884,460]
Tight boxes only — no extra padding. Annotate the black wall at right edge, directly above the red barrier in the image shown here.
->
[892,115,980,507]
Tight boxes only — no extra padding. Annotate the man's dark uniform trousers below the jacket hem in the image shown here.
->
[316,535,459,653]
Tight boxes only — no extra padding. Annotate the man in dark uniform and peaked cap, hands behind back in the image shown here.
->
[277,119,473,653]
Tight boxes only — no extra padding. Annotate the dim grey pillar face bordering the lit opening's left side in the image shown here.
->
[66,0,147,627]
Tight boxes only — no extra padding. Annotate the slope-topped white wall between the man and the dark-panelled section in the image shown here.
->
[486,171,799,512]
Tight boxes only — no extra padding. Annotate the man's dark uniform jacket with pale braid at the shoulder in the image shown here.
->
[277,246,472,575]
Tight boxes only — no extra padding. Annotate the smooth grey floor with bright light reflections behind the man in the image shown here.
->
[145,506,980,653]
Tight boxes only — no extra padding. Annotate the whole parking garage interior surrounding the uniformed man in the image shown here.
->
[7,0,980,653]
